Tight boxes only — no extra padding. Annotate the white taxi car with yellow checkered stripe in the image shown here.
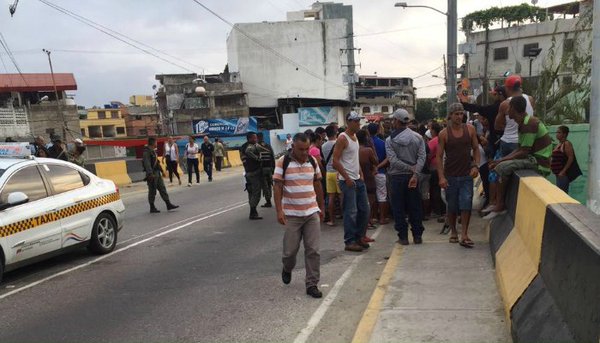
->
[0,143,125,281]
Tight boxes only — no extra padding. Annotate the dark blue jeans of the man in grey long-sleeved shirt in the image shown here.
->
[390,175,425,239]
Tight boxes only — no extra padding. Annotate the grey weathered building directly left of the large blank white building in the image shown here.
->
[156,74,249,135]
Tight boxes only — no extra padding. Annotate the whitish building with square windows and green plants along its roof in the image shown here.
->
[459,0,592,102]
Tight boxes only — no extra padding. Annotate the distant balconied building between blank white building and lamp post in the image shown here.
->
[355,76,415,120]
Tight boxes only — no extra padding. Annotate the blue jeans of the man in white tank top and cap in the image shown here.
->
[338,180,369,244]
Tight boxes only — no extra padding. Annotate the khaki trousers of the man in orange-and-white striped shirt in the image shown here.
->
[282,212,321,288]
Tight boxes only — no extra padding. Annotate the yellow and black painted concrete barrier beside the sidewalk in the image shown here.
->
[490,171,600,342]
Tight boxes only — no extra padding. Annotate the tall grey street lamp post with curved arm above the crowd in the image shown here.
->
[394,0,458,115]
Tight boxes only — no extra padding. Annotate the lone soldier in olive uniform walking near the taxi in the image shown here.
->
[142,137,179,213]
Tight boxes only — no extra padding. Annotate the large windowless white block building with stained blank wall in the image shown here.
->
[227,3,354,108]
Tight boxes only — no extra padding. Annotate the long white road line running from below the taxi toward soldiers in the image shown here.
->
[0,203,246,299]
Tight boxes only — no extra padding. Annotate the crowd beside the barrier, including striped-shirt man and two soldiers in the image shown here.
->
[241,75,576,298]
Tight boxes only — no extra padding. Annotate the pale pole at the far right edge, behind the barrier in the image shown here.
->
[587,0,600,214]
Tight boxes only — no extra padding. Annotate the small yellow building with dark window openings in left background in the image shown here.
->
[79,105,127,139]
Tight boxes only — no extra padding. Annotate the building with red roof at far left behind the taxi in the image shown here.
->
[0,73,80,141]
